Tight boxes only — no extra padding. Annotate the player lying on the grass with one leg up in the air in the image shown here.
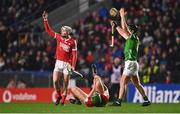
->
[70,65,109,107]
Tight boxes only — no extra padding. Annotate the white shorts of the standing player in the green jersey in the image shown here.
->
[123,60,139,76]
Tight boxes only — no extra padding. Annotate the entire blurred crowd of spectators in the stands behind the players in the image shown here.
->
[0,0,180,89]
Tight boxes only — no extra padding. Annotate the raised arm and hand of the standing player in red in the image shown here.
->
[42,11,56,38]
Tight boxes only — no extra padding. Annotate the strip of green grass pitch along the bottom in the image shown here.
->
[0,103,180,113]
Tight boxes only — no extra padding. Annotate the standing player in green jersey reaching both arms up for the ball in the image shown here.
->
[111,8,151,106]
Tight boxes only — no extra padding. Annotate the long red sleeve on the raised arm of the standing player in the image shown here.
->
[44,19,57,38]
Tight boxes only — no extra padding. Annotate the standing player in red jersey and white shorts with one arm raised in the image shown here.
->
[42,11,77,105]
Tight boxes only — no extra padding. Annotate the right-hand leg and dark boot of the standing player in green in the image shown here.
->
[131,76,151,106]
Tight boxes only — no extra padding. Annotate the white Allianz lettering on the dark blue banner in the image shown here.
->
[133,86,180,103]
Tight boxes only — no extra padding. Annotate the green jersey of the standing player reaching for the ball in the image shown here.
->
[124,33,139,61]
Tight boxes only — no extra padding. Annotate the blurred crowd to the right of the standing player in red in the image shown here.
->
[74,0,180,84]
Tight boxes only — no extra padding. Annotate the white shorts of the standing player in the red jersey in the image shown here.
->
[54,60,71,75]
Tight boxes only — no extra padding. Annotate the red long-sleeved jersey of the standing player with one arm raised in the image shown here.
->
[44,20,77,67]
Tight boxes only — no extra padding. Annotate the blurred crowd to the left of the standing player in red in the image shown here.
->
[0,0,66,71]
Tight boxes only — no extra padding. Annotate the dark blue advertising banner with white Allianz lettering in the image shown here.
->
[127,84,180,103]
